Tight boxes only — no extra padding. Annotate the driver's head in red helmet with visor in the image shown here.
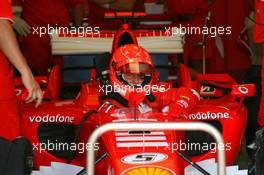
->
[110,44,154,100]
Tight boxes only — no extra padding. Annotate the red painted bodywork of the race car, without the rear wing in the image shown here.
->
[18,20,254,175]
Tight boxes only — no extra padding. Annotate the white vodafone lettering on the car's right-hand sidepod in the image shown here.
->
[189,111,230,120]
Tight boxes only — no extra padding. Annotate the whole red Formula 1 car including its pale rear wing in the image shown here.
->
[18,15,254,175]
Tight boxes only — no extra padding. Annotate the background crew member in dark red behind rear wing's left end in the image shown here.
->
[13,0,83,75]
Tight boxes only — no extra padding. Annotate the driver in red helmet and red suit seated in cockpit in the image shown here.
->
[98,44,200,117]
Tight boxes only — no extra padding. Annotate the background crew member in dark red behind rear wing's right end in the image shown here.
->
[164,0,214,73]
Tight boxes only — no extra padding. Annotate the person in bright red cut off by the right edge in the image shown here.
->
[254,0,264,126]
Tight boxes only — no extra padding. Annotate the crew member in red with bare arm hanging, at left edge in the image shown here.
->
[0,0,42,140]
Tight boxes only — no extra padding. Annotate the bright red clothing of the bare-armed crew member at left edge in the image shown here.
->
[0,0,20,140]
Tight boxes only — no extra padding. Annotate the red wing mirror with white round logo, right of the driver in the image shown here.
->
[231,84,256,97]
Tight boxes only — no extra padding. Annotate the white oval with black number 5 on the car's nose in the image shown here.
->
[122,153,168,164]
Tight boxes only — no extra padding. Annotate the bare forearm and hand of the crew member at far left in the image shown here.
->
[0,19,42,107]
